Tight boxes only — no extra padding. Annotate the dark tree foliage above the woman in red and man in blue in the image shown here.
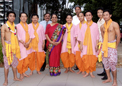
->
[23,0,73,24]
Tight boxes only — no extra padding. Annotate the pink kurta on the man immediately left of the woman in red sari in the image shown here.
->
[29,23,46,52]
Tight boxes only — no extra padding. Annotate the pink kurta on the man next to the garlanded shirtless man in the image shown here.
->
[16,24,35,60]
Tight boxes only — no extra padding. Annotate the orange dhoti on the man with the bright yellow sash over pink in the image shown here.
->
[61,52,75,68]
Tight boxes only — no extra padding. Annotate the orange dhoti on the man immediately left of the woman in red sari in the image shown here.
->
[29,52,45,71]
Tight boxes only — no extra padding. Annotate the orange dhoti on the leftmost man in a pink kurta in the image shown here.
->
[17,54,30,74]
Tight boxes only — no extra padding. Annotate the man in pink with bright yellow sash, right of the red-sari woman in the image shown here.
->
[61,14,75,73]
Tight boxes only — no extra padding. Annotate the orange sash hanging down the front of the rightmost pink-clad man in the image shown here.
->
[83,21,93,55]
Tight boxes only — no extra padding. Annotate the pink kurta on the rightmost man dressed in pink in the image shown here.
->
[78,23,99,57]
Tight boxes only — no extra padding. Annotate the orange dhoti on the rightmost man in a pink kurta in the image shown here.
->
[82,55,97,73]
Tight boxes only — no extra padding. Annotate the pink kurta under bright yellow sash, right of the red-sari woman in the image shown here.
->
[61,25,76,54]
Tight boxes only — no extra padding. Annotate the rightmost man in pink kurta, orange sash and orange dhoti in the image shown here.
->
[78,11,99,77]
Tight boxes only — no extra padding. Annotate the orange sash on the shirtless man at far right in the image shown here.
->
[102,19,112,57]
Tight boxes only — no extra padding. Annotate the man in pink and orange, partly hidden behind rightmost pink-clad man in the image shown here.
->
[74,13,86,75]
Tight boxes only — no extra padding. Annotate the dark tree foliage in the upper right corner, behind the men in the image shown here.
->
[69,0,122,22]
